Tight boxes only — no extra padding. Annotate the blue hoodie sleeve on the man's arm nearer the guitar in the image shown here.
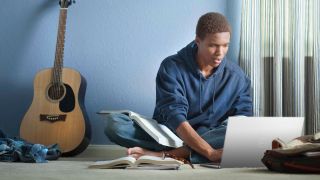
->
[155,59,188,132]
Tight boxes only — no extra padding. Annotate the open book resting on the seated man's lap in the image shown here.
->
[98,110,183,148]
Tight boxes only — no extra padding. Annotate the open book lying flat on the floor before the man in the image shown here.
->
[89,155,183,169]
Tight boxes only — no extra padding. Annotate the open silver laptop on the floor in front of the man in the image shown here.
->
[201,116,304,168]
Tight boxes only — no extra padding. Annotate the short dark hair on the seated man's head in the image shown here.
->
[196,12,231,39]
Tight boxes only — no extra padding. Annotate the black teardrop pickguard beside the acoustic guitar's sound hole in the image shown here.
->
[59,84,75,113]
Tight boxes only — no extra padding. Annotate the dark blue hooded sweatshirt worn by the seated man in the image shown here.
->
[153,41,252,132]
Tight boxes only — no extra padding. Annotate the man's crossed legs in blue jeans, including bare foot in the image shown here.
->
[105,114,226,163]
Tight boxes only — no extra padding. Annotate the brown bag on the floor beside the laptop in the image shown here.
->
[262,133,320,173]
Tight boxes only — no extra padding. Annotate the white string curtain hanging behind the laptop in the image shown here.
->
[239,0,320,134]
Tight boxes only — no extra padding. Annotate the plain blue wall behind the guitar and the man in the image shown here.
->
[0,0,240,144]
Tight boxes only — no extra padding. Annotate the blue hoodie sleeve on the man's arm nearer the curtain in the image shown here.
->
[232,77,253,116]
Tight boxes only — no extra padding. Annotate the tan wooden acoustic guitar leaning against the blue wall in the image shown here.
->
[20,0,91,156]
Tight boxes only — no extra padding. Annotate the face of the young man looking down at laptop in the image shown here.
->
[196,32,230,68]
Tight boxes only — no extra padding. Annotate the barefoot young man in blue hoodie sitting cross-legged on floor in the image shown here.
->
[105,13,252,163]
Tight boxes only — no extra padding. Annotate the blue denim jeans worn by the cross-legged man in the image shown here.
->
[104,114,227,163]
